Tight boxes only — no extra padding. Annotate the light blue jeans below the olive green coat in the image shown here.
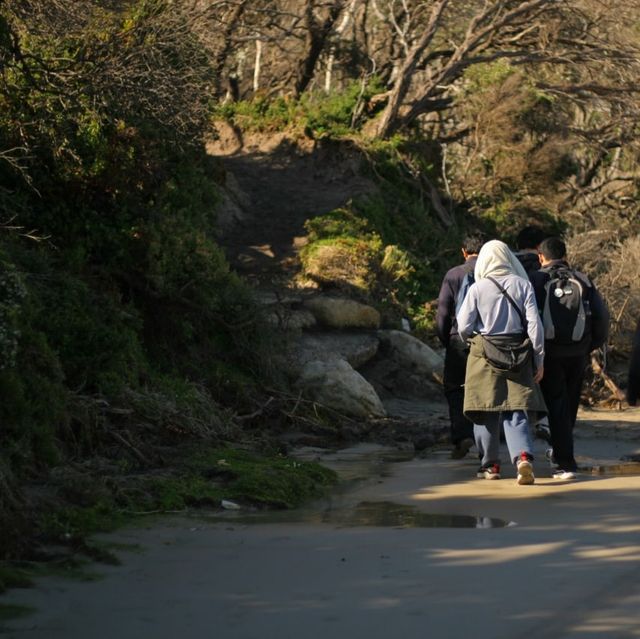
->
[473,410,533,466]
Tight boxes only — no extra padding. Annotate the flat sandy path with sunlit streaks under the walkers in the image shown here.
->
[3,410,640,639]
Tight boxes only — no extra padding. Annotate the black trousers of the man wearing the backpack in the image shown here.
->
[540,354,587,470]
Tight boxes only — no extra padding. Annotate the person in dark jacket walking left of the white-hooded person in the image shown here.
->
[436,233,486,459]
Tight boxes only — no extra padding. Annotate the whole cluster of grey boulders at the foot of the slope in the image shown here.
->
[256,291,443,419]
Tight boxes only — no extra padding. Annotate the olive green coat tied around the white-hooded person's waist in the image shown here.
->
[464,335,547,424]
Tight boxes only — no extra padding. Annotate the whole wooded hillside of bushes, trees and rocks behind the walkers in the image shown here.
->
[0,0,640,556]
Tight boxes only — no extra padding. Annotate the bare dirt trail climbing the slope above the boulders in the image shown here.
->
[207,125,375,282]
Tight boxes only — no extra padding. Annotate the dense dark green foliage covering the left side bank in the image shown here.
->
[0,0,274,556]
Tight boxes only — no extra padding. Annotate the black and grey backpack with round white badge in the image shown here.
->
[541,266,591,345]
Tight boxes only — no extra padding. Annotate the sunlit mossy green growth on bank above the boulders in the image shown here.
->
[300,136,458,328]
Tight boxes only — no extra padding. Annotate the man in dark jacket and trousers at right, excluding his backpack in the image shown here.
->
[529,237,609,480]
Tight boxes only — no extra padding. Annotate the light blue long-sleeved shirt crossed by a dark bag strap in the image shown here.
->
[456,275,544,368]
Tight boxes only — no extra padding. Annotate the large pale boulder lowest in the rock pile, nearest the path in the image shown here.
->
[297,359,386,418]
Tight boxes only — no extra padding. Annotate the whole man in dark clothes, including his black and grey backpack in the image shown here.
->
[529,237,609,480]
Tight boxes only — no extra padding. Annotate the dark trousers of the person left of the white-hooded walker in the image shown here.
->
[442,335,473,446]
